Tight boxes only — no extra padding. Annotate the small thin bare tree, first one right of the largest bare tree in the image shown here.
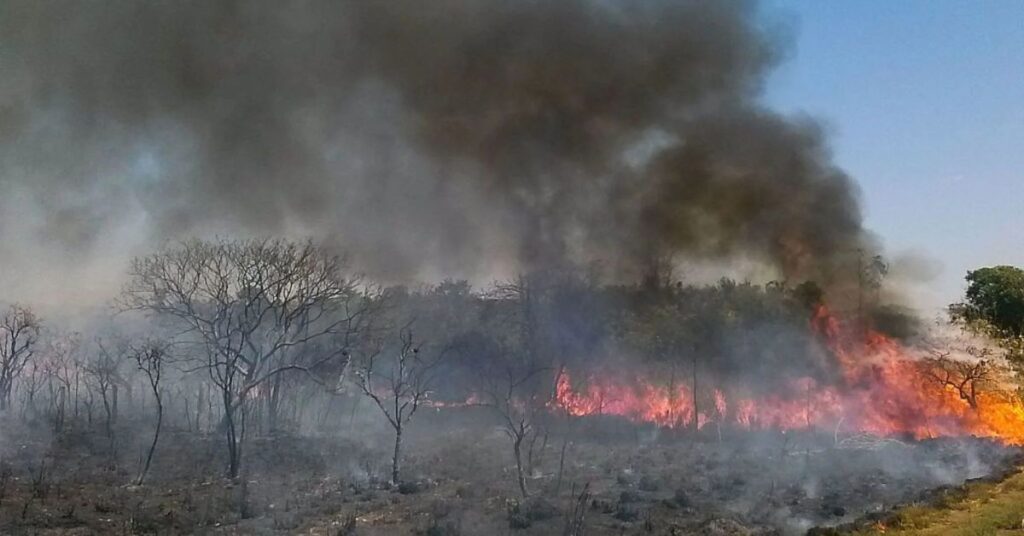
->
[355,323,447,485]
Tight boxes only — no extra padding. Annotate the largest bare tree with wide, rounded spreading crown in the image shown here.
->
[123,240,374,478]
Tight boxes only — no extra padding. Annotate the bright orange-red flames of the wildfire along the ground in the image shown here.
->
[554,306,1024,445]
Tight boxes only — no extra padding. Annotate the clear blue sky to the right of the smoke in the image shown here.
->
[764,0,1024,306]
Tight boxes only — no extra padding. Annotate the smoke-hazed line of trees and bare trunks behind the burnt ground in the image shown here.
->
[0,240,872,494]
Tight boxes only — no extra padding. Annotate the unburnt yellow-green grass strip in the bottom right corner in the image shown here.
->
[853,471,1024,536]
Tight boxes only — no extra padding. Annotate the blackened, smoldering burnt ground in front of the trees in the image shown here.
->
[0,408,1018,536]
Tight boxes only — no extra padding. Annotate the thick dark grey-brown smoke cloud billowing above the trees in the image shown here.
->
[0,0,864,305]
